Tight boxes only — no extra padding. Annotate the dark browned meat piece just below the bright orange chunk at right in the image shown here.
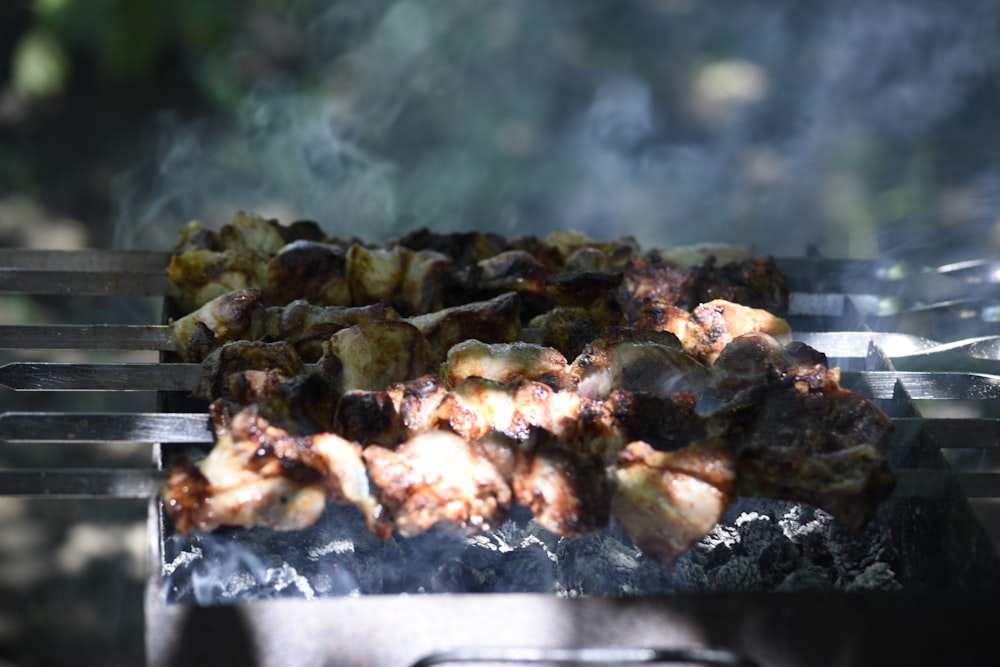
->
[712,333,840,399]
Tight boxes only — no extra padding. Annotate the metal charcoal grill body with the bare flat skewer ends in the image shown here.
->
[0,251,1000,665]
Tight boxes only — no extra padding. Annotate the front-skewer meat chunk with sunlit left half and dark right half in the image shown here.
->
[513,431,611,535]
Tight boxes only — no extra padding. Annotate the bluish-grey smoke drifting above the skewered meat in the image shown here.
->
[111,0,1000,255]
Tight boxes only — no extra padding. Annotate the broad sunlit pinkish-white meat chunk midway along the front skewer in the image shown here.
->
[364,431,512,537]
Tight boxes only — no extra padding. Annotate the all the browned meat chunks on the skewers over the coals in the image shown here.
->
[163,216,892,566]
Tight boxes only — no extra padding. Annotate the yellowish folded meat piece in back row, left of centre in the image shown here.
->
[347,243,452,315]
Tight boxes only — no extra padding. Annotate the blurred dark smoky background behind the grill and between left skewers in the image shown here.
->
[0,0,1000,666]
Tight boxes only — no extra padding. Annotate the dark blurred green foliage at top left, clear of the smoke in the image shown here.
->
[0,0,306,245]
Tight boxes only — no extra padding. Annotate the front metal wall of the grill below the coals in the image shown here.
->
[146,591,997,667]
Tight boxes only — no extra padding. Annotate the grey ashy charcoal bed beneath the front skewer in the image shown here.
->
[162,499,902,605]
